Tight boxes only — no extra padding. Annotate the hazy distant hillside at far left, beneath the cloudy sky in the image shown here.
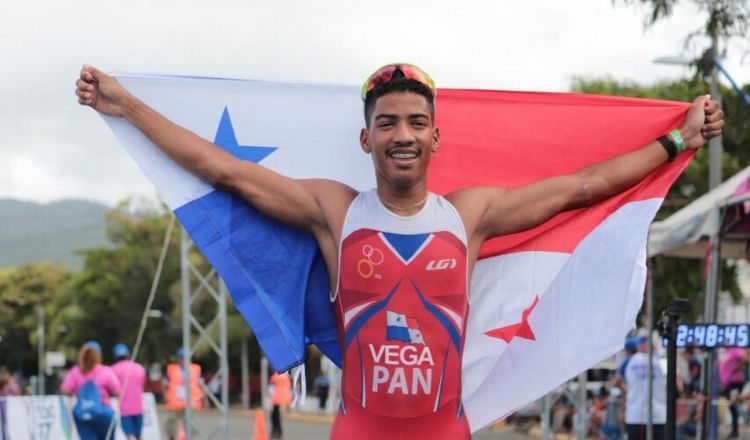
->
[0,199,110,269]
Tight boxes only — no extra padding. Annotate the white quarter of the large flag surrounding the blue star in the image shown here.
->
[106,75,375,209]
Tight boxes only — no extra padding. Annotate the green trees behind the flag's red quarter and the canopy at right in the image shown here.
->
[571,78,750,318]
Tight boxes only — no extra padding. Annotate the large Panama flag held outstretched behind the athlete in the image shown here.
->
[107,75,690,431]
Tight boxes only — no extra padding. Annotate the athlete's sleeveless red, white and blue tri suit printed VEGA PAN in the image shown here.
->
[331,190,471,440]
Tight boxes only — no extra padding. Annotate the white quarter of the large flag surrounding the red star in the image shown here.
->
[463,199,661,428]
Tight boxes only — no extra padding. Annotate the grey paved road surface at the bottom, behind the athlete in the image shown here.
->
[169,410,530,440]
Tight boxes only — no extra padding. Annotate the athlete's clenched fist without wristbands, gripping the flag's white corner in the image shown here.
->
[76,64,130,116]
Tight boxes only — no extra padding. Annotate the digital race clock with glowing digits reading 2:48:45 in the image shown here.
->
[676,324,750,348]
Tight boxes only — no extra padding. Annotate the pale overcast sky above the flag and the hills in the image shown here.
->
[0,0,750,205]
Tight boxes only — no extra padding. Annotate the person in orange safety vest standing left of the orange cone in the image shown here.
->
[164,348,203,440]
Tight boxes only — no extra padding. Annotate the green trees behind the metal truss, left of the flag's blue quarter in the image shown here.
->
[58,200,259,390]
